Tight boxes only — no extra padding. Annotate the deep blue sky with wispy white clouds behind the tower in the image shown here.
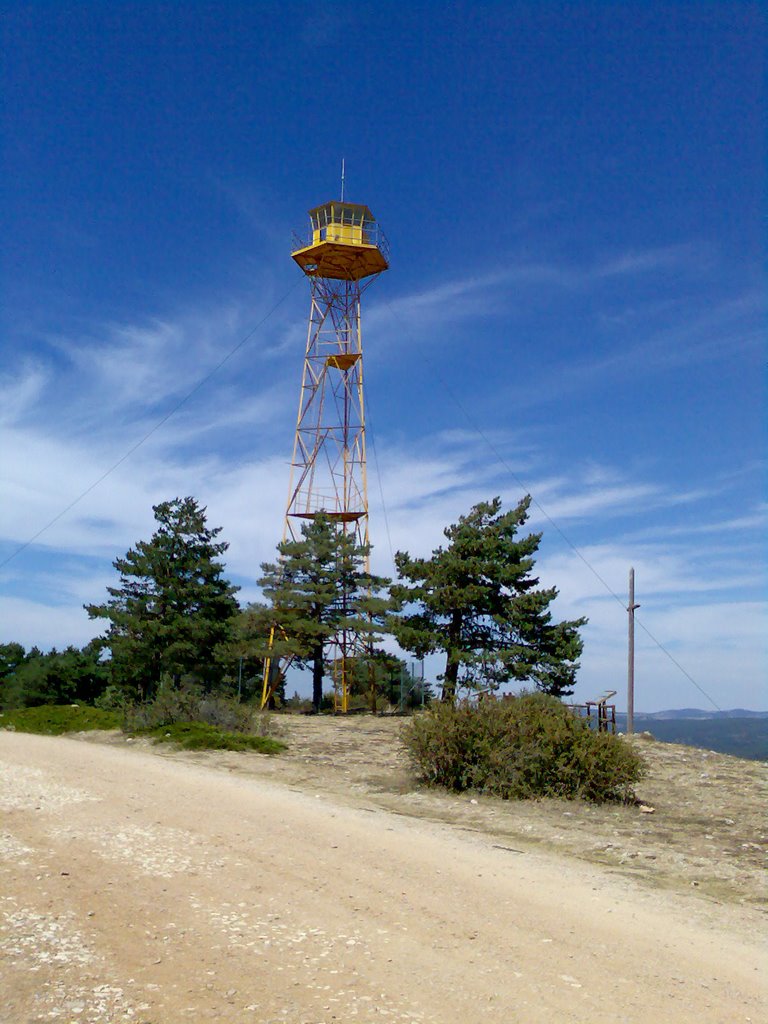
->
[0,0,767,711]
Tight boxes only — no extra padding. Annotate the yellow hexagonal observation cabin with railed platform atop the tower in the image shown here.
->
[291,201,389,281]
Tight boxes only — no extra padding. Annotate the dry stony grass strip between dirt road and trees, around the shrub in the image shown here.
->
[173,716,768,908]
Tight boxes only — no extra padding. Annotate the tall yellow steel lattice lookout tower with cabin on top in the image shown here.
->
[261,200,389,712]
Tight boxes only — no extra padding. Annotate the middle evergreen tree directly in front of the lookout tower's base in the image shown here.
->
[257,515,391,711]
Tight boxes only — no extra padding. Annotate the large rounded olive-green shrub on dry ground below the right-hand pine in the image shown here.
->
[402,693,645,803]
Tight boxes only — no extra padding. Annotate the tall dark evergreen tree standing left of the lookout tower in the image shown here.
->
[85,498,238,698]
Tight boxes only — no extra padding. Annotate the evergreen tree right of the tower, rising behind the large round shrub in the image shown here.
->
[390,497,587,700]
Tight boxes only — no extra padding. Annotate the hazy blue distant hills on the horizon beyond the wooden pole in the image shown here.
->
[616,708,768,761]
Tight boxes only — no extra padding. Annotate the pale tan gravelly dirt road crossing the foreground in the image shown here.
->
[0,732,768,1024]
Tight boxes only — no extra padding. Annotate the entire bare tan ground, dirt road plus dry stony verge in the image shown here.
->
[0,717,768,1024]
